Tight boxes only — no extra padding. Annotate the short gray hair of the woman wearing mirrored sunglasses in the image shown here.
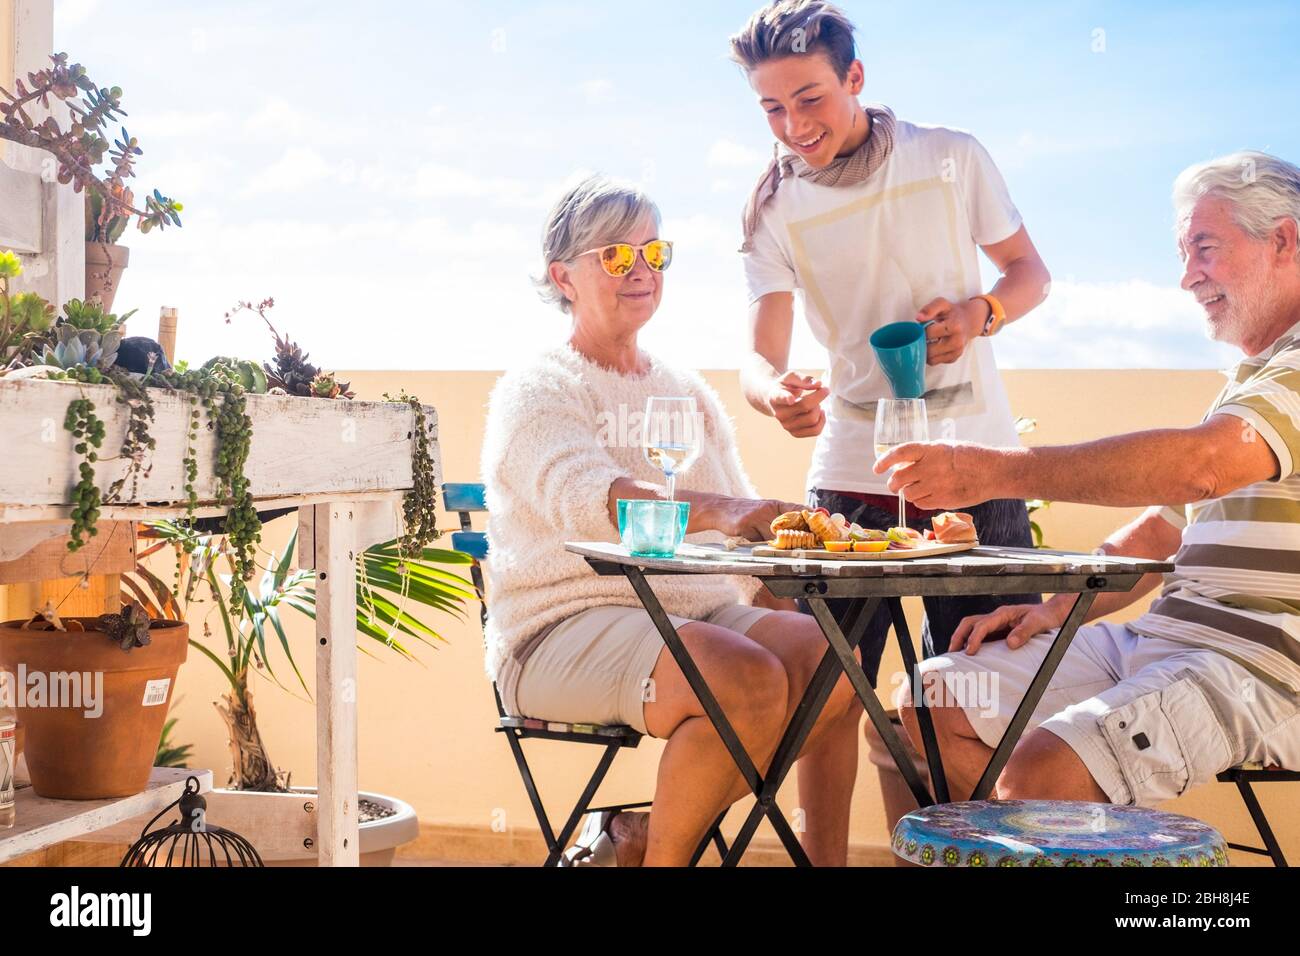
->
[533,173,660,312]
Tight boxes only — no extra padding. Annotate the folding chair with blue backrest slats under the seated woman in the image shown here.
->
[442,483,727,866]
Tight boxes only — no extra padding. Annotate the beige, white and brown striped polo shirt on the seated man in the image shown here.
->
[1128,324,1300,695]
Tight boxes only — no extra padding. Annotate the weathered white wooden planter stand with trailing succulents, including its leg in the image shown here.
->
[0,378,441,865]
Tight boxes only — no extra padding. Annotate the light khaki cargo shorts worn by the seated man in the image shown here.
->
[920,623,1300,806]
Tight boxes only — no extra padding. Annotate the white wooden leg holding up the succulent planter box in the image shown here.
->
[312,501,360,866]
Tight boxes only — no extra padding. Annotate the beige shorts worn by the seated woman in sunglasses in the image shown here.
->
[497,605,771,734]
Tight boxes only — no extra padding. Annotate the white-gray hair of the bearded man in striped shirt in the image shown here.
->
[1174,150,1300,256]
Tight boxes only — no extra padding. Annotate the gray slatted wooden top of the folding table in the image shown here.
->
[564,541,1174,578]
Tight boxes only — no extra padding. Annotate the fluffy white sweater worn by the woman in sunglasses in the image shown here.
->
[482,345,758,679]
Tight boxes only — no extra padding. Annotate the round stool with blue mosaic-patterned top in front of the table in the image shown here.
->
[893,800,1229,866]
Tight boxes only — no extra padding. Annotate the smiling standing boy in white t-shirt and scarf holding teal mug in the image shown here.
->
[731,0,1050,842]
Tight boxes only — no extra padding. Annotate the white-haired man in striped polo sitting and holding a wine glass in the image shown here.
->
[876,152,1300,805]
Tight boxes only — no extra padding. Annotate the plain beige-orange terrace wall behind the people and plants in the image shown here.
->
[131,371,1300,849]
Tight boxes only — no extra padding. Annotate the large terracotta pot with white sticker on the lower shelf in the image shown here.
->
[0,618,190,800]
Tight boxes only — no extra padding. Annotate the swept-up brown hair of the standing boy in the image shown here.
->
[731,0,857,81]
